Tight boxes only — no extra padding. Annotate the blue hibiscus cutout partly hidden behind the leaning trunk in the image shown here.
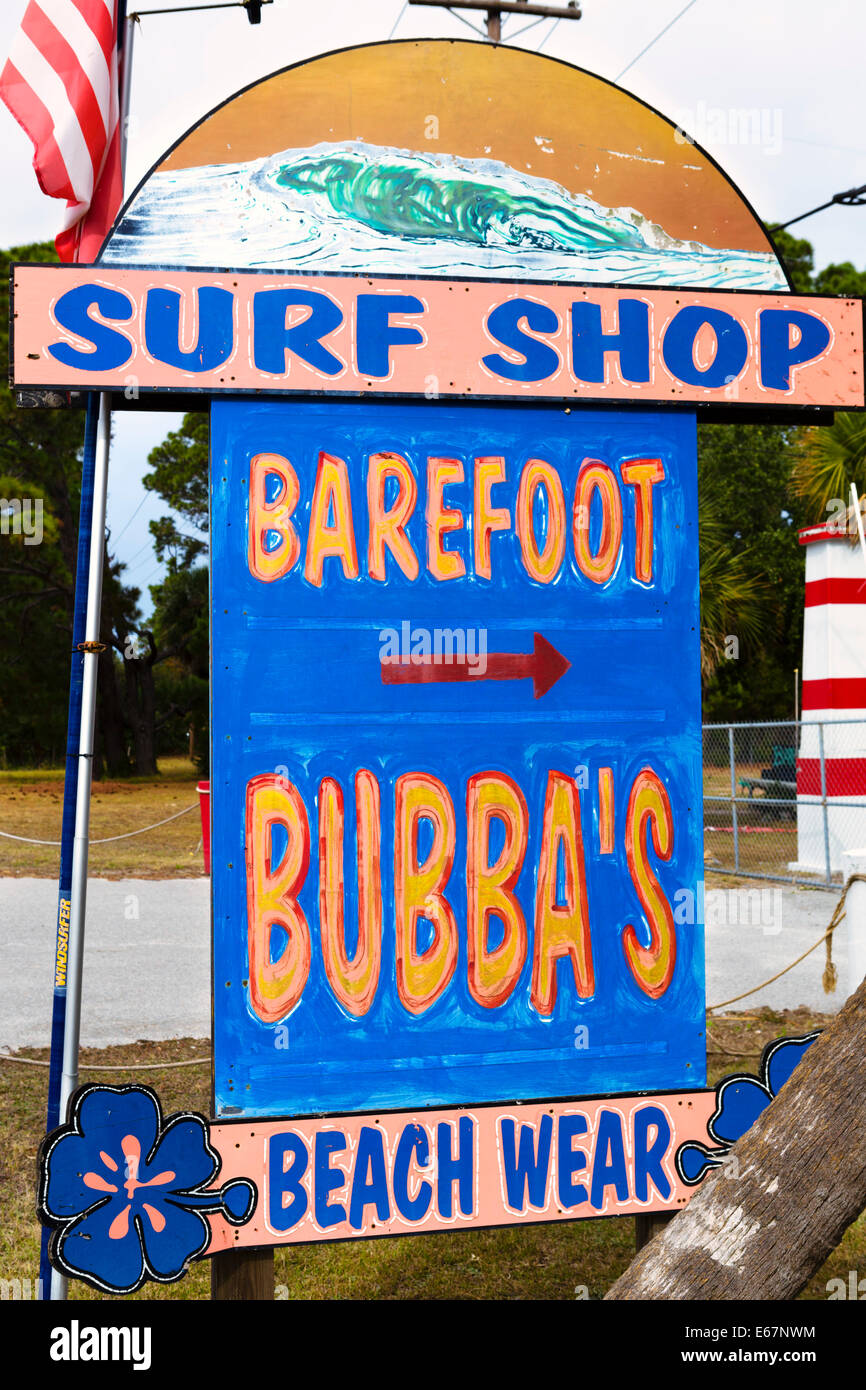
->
[676,1033,819,1187]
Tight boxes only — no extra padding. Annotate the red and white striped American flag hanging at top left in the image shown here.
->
[0,0,122,261]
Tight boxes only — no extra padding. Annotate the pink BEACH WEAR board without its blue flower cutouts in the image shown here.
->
[209,1091,716,1254]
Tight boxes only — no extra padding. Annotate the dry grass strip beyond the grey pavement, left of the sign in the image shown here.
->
[0,758,204,878]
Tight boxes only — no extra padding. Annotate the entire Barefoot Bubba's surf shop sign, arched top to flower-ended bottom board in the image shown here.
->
[23,42,863,1291]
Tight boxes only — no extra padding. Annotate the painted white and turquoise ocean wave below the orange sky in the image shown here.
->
[101,142,787,289]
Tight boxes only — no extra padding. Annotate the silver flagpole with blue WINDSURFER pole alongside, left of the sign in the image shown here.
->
[39,0,135,1301]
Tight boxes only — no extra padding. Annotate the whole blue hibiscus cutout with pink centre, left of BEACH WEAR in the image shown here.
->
[38,1086,257,1294]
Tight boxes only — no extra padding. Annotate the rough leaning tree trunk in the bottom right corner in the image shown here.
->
[606,981,866,1300]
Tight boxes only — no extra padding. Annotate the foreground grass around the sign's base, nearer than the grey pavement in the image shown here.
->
[0,1009,866,1300]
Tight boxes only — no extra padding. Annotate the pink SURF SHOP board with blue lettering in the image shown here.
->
[14,265,865,410]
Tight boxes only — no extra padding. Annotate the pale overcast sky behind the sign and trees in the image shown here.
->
[0,0,866,609]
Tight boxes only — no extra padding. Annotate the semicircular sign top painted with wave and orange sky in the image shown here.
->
[100,39,790,291]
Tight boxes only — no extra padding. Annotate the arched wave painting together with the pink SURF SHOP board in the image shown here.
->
[13,39,863,405]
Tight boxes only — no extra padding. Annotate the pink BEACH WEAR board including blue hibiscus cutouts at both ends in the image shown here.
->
[36,1033,819,1294]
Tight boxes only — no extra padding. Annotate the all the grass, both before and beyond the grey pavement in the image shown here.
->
[0,778,866,1300]
